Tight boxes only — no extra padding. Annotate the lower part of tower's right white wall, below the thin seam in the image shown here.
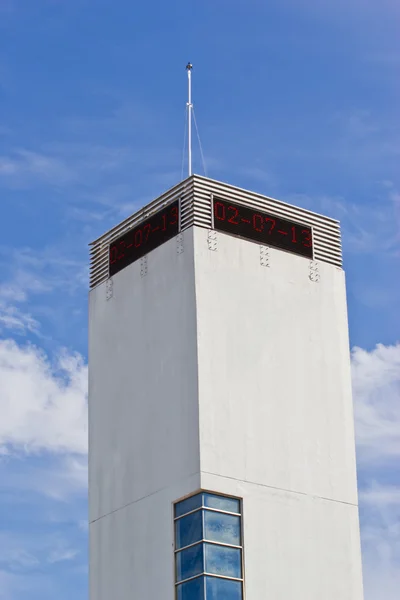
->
[201,473,363,600]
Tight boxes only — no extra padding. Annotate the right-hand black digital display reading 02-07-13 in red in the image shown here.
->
[212,198,313,258]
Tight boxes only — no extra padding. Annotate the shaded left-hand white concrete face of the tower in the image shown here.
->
[89,230,200,600]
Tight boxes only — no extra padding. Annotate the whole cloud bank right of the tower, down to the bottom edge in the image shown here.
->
[352,344,400,600]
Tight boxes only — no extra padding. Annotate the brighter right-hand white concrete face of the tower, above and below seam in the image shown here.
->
[195,229,362,600]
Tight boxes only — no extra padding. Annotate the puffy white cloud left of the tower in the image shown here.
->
[0,340,87,455]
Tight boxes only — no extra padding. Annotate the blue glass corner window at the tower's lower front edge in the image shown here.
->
[174,492,243,600]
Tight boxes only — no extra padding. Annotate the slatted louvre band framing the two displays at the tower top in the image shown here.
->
[90,175,342,288]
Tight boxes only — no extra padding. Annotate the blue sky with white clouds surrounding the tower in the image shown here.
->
[0,0,400,600]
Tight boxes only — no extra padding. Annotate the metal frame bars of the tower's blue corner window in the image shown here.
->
[172,489,245,600]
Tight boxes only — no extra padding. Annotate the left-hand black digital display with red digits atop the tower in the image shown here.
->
[109,200,180,277]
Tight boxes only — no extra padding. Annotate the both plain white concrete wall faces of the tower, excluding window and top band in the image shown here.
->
[89,228,362,600]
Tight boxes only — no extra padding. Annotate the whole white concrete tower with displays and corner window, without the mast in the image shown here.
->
[89,175,363,600]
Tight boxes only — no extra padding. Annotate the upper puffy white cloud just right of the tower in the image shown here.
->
[352,344,400,464]
